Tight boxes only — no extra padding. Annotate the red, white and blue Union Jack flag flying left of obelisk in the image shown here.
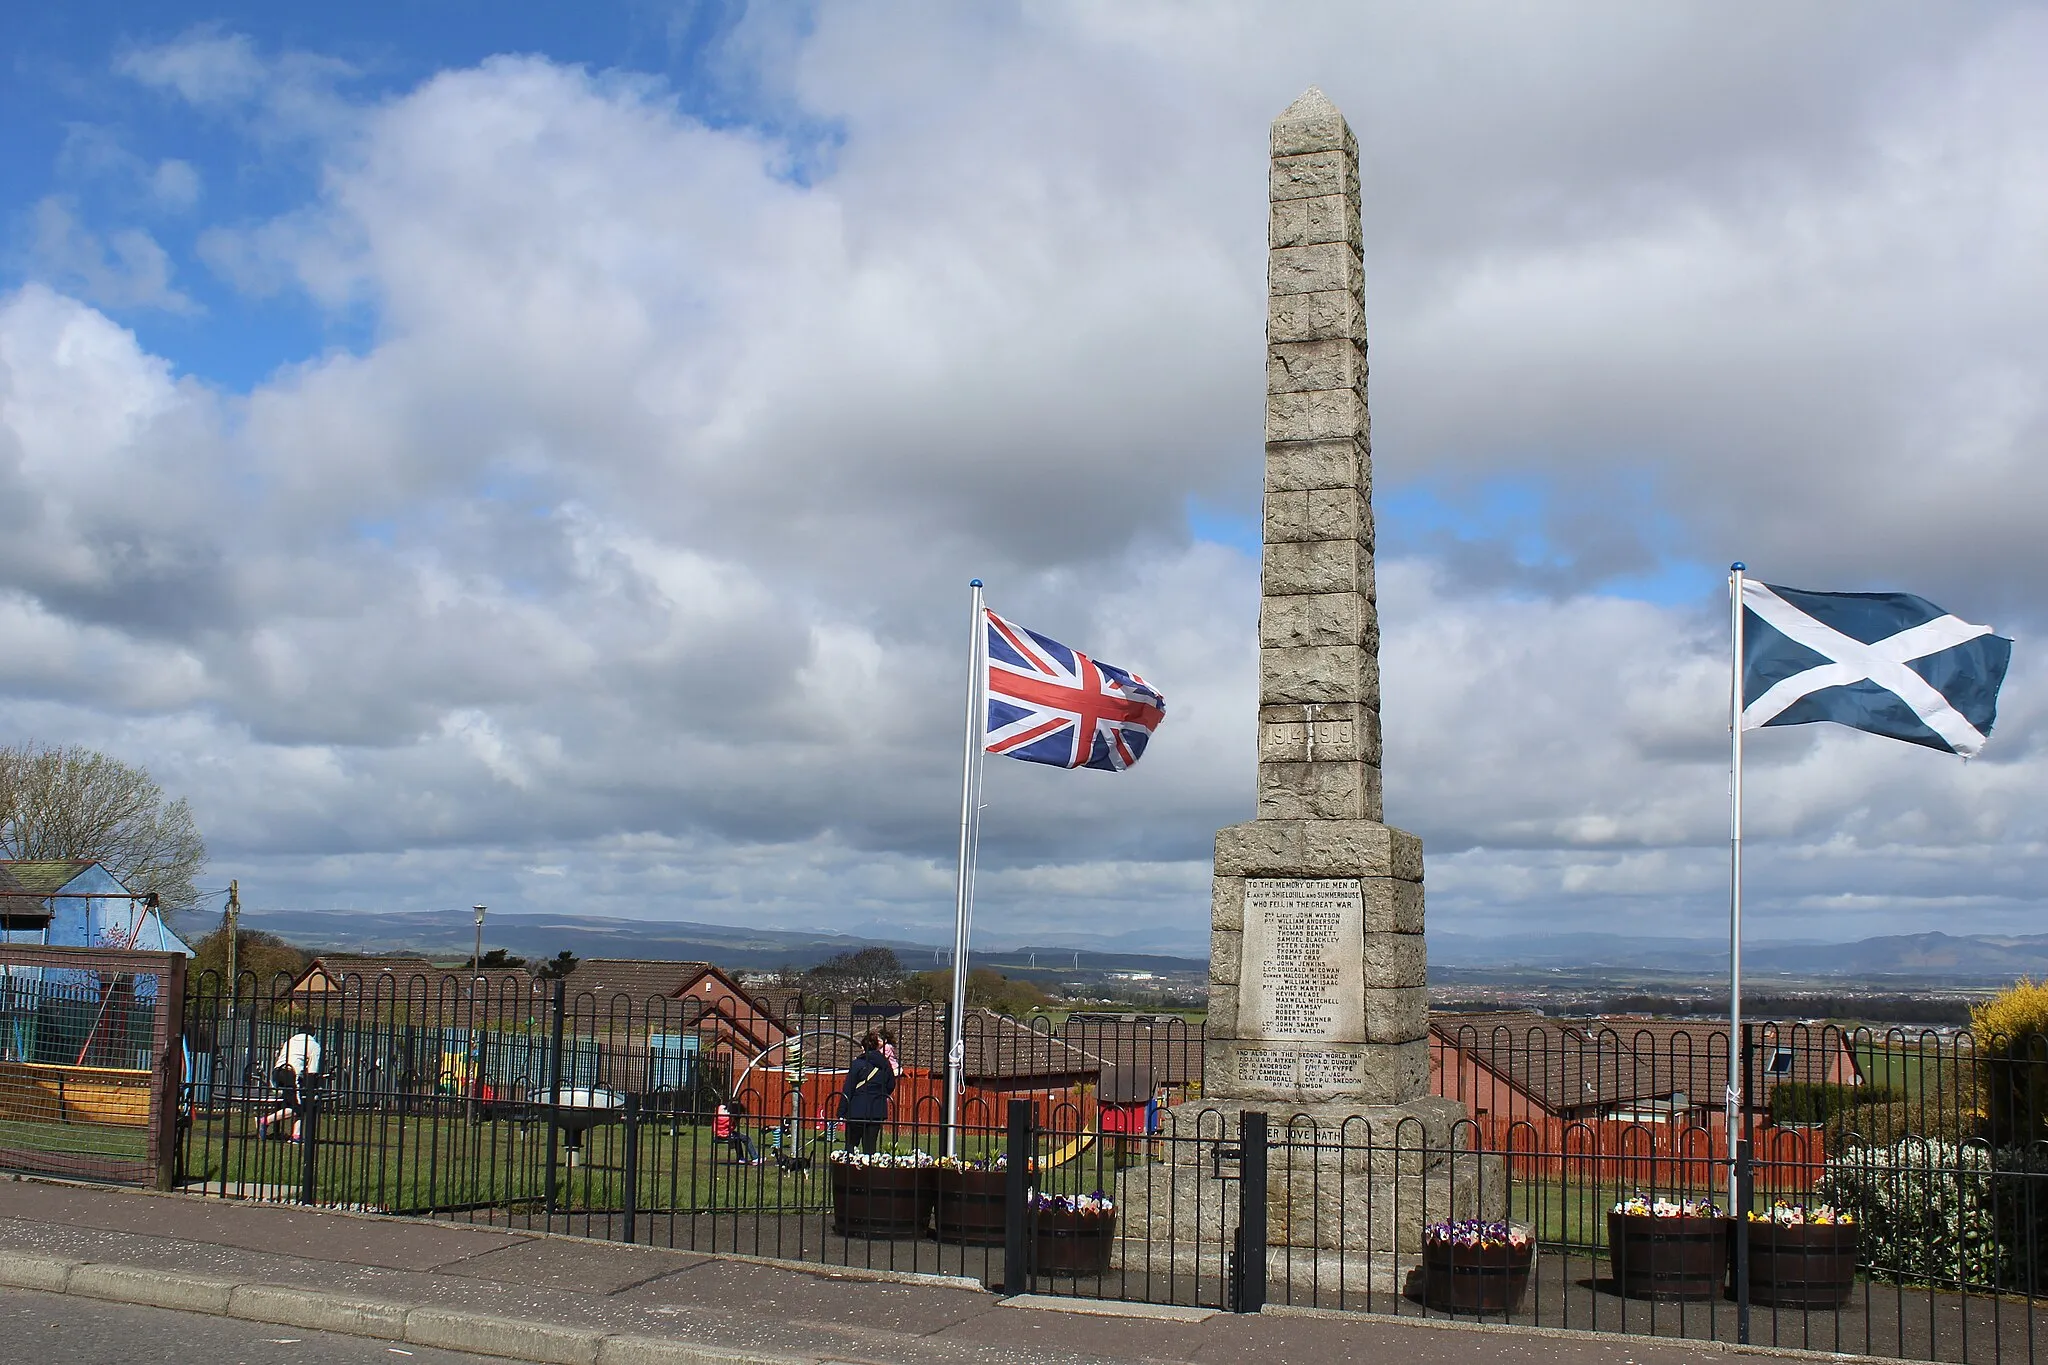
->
[981,610,1165,772]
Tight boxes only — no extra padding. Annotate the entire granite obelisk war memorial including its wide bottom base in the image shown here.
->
[1120,88,1499,1279]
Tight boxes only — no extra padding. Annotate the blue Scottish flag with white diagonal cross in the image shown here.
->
[1743,579,2013,757]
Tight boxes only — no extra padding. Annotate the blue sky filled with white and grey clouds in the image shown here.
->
[0,0,2048,952]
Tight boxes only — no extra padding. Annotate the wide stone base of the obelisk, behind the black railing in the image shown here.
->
[1114,1097,1507,1291]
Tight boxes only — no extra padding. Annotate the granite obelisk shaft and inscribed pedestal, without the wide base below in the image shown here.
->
[1204,90,1430,1105]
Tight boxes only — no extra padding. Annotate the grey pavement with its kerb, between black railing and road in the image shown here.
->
[0,1181,1916,1365]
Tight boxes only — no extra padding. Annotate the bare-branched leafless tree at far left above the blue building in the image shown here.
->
[0,743,207,909]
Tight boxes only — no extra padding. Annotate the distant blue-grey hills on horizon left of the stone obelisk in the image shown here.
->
[228,911,1208,976]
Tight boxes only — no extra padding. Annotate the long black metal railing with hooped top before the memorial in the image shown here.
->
[28,972,2048,1361]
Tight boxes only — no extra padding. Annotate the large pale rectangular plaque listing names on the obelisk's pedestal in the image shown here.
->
[1241,878,1366,1042]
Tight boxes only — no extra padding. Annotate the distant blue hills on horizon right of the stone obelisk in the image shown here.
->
[1430,933,2048,980]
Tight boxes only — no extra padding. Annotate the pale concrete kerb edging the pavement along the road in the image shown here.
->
[0,1252,823,1365]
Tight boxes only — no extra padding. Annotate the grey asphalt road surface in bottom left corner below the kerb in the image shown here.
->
[0,1289,504,1365]
